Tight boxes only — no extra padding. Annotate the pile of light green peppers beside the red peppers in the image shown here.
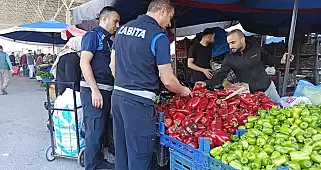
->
[210,104,321,170]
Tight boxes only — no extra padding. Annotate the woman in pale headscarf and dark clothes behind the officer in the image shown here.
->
[52,37,82,95]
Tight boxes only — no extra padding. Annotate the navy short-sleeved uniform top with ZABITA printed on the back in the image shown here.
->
[113,15,171,104]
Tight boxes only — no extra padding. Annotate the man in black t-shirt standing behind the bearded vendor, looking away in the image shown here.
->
[188,28,215,84]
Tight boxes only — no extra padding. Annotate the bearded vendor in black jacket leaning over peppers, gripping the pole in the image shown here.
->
[201,29,294,102]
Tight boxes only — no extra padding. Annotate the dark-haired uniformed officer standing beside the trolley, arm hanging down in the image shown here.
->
[80,6,120,170]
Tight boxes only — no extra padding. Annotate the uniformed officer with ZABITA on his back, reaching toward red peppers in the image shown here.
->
[110,0,190,170]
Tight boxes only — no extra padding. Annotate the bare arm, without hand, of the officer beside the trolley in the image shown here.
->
[80,51,99,91]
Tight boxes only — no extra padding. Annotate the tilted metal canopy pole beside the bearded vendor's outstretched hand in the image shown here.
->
[281,0,299,96]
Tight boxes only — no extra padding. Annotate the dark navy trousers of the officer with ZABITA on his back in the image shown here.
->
[112,94,156,170]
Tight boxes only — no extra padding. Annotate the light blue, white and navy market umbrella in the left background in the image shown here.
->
[0,20,67,44]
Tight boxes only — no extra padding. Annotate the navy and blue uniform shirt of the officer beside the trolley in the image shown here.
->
[81,26,114,85]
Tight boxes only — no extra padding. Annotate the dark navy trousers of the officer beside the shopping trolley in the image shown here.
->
[80,87,112,170]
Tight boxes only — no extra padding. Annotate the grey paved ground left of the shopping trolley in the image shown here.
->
[0,77,83,170]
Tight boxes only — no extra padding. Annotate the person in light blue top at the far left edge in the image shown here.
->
[0,46,12,95]
